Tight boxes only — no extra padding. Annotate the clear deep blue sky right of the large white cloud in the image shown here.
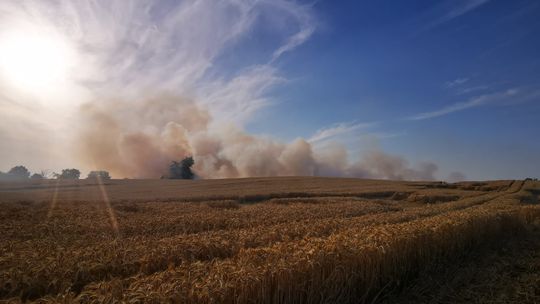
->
[245,1,540,179]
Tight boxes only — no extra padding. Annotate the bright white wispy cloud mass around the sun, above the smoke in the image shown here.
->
[0,0,316,171]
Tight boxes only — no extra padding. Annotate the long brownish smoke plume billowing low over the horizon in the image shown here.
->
[77,95,452,180]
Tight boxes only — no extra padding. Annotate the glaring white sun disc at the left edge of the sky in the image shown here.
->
[0,30,74,94]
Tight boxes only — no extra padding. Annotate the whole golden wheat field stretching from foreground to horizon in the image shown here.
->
[0,177,540,303]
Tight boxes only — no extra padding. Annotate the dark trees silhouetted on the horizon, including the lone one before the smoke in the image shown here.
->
[0,156,195,181]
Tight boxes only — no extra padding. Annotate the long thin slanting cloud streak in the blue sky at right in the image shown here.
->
[407,89,525,120]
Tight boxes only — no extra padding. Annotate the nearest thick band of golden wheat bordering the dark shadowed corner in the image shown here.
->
[87,201,538,303]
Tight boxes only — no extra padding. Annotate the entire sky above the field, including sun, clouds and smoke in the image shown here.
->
[0,0,540,181]
